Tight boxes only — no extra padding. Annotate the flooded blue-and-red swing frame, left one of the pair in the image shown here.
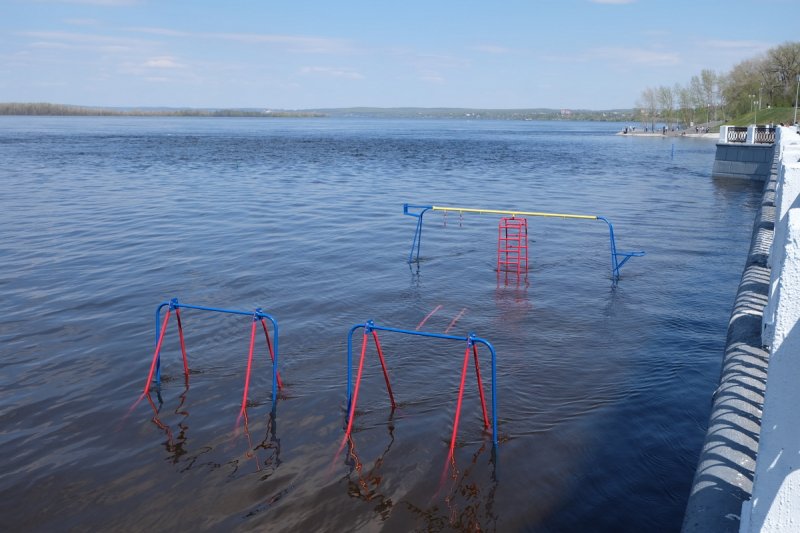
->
[144,298,283,415]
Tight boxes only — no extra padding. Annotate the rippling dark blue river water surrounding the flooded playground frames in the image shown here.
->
[0,117,760,532]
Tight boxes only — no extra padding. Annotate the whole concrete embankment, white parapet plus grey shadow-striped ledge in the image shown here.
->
[683,128,800,532]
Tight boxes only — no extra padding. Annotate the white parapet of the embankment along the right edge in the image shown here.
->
[740,128,800,533]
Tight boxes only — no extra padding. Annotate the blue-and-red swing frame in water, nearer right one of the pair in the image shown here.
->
[344,320,497,457]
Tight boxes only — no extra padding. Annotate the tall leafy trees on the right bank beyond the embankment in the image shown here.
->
[636,42,800,128]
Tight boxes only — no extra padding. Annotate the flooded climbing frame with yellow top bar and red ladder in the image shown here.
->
[403,204,644,286]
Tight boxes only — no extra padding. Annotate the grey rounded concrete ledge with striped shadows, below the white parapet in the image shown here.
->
[683,139,776,533]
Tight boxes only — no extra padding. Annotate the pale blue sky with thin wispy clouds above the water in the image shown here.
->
[0,0,800,109]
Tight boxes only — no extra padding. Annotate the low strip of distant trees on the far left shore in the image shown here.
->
[0,102,325,117]
